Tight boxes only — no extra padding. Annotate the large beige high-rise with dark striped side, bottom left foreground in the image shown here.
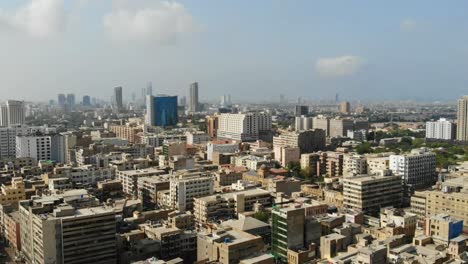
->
[19,196,117,264]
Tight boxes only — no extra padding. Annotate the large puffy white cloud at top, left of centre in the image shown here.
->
[103,1,198,44]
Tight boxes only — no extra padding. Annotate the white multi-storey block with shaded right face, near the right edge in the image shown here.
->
[390,148,437,188]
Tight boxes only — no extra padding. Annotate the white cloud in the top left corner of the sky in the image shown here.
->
[0,0,66,37]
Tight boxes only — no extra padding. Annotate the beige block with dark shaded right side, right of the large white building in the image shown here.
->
[273,129,326,154]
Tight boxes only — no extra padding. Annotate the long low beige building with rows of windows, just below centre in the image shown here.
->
[194,189,271,223]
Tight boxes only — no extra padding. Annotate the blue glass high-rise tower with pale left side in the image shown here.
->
[146,95,179,127]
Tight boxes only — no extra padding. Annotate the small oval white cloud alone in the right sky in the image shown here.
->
[315,55,364,78]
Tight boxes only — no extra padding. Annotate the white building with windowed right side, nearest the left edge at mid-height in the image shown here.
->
[16,136,52,161]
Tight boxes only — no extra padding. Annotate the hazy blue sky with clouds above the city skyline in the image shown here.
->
[0,0,468,101]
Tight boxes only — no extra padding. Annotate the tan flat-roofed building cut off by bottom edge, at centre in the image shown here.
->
[197,229,265,264]
